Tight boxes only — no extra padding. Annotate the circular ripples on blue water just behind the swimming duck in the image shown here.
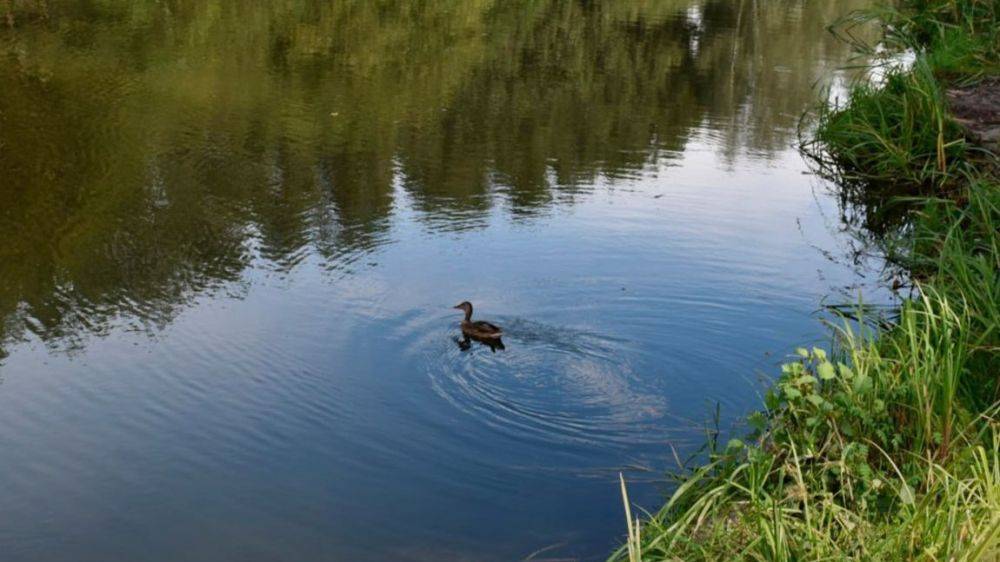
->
[410,318,667,445]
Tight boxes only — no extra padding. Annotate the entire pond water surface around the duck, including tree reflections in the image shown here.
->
[0,0,876,562]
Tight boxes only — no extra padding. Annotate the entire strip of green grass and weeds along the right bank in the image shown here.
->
[611,0,1000,562]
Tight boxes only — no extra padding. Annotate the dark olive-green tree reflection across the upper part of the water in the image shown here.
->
[0,0,860,350]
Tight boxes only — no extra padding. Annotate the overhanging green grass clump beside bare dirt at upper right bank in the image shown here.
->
[802,0,1000,200]
